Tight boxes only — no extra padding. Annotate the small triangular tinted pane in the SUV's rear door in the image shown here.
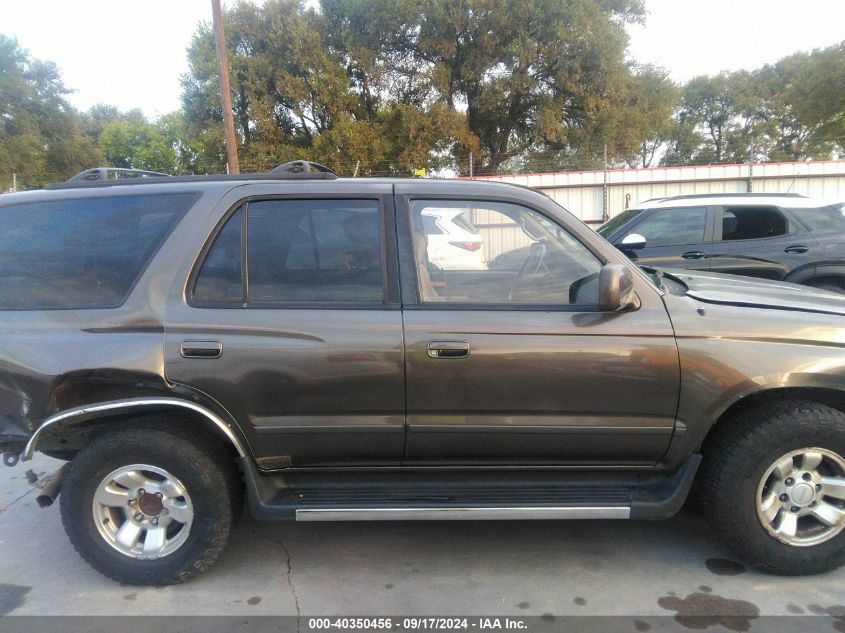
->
[194,209,244,303]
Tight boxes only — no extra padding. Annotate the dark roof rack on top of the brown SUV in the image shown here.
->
[45,160,339,189]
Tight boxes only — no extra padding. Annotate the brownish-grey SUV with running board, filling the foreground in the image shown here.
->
[0,165,845,585]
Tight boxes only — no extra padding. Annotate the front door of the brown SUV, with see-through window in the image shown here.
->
[397,191,679,465]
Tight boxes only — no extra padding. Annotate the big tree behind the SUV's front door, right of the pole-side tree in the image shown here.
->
[322,0,644,172]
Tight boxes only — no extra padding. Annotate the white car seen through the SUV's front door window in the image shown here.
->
[422,208,487,270]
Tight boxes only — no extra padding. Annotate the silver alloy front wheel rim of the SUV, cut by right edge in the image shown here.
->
[756,448,845,547]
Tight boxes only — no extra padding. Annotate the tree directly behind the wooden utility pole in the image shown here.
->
[182,0,471,174]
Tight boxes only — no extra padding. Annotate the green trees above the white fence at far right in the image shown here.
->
[663,42,845,164]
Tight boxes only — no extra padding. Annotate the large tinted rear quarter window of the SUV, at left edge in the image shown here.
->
[0,193,195,310]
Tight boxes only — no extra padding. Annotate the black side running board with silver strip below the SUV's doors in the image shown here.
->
[241,455,701,521]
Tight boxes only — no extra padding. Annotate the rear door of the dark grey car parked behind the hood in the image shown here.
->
[711,205,819,281]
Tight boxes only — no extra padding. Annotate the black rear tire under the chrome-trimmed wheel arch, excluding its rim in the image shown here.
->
[60,424,241,585]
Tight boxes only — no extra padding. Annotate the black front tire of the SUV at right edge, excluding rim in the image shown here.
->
[698,400,845,576]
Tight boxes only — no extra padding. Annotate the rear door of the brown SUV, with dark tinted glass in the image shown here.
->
[166,184,405,468]
